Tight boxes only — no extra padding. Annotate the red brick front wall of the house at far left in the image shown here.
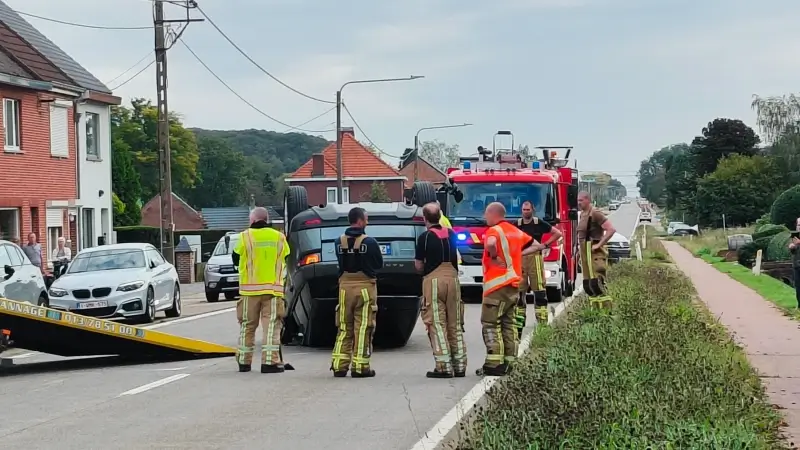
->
[0,85,77,261]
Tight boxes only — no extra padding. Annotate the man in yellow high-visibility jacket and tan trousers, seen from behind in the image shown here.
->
[231,207,289,373]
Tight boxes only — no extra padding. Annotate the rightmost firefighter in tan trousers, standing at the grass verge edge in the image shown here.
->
[577,192,617,308]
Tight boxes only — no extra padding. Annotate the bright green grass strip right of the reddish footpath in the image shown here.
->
[670,228,800,319]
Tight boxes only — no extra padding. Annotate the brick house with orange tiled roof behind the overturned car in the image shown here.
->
[286,128,406,205]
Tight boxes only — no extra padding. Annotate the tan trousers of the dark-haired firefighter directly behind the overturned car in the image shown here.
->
[331,272,378,372]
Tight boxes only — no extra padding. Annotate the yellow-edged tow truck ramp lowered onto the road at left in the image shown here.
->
[0,298,236,361]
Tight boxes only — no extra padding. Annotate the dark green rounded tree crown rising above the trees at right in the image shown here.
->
[692,118,761,177]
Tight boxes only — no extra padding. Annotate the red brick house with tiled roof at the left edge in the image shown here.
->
[0,2,121,262]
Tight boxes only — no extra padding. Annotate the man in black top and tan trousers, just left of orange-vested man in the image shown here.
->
[414,203,467,378]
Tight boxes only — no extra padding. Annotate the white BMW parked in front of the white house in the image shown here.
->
[50,244,181,323]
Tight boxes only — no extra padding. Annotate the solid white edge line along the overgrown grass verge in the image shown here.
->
[411,206,639,450]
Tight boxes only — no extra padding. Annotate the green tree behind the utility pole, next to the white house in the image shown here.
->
[111,98,199,201]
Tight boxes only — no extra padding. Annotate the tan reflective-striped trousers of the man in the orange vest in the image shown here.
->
[481,285,519,368]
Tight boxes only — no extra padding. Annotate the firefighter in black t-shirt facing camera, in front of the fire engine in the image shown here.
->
[517,200,562,337]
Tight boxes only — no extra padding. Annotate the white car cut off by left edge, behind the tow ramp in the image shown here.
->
[0,240,49,306]
